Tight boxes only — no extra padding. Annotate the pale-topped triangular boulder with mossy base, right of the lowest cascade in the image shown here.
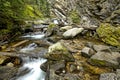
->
[45,42,74,61]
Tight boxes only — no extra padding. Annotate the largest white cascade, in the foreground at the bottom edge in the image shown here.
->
[14,57,47,80]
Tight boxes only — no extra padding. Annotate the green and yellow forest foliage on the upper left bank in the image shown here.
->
[0,0,50,40]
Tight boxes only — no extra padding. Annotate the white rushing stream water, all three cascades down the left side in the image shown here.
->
[11,24,47,80]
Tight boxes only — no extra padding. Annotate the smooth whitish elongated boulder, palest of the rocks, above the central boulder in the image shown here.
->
[63,28,84,38]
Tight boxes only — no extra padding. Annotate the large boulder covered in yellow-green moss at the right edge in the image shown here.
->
[96,23,120,47]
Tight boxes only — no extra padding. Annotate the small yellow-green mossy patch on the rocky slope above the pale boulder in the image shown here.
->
[69,10,80,23]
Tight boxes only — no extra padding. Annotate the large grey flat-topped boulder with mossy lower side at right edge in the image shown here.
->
[89,52,120,68]
